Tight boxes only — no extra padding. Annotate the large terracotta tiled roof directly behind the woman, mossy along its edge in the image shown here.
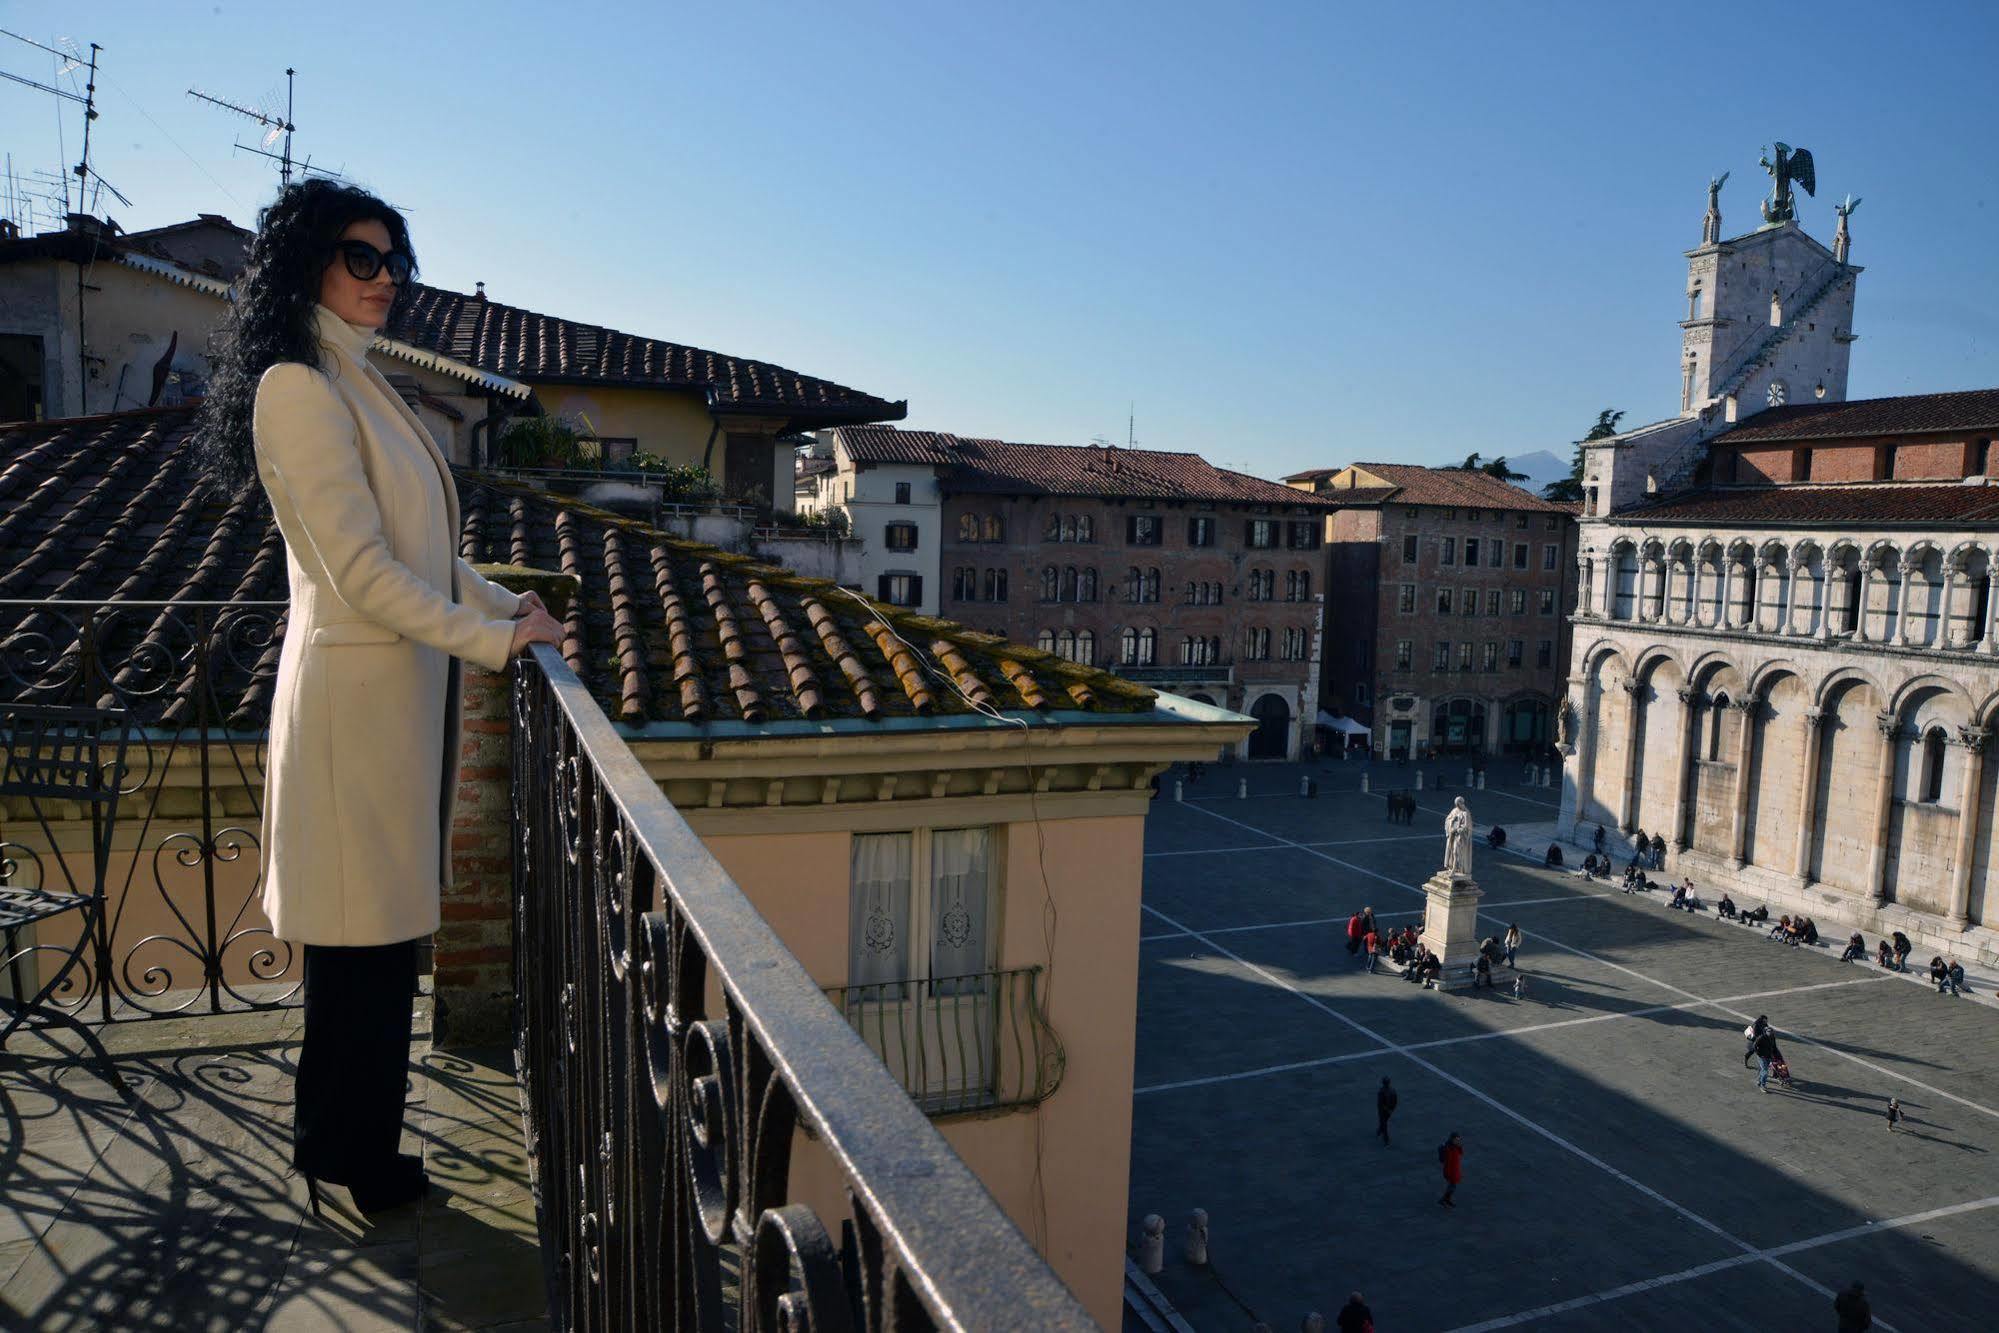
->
[0,406,1155,729]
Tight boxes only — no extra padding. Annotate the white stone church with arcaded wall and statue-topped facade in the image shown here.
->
[1557,161,1999,961]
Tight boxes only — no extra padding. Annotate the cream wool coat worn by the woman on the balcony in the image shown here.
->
[254,304,520,945]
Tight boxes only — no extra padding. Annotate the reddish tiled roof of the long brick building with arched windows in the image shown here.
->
[836,426,1327,510]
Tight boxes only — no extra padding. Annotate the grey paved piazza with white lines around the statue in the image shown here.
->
[1131,761,1999,1333]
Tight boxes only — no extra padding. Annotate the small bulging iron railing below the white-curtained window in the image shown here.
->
[826,967,1065,1115]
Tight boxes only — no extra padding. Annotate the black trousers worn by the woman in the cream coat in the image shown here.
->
[292,939,418,1185]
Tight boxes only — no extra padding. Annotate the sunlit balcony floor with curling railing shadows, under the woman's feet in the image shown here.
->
[0,995,548,1333]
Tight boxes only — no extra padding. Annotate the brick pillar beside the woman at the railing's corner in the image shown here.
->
[432,566,574,1047]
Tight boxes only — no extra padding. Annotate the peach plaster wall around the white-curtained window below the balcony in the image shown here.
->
[702,797,1145,1329]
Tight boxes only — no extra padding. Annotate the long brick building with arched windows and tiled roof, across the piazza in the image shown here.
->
[836,426,1329,757]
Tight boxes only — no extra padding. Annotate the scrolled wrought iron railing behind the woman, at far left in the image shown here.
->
[0,600,300,1021]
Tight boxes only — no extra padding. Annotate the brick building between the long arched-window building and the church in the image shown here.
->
[1287,464,1575,757]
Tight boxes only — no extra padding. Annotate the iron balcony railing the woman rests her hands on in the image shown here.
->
[512,644,1095,1333]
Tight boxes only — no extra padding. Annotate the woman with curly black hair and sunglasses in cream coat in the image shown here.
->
[198,180,560,1213]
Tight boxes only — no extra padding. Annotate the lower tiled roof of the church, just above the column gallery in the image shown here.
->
[1609,482,1999,528]
